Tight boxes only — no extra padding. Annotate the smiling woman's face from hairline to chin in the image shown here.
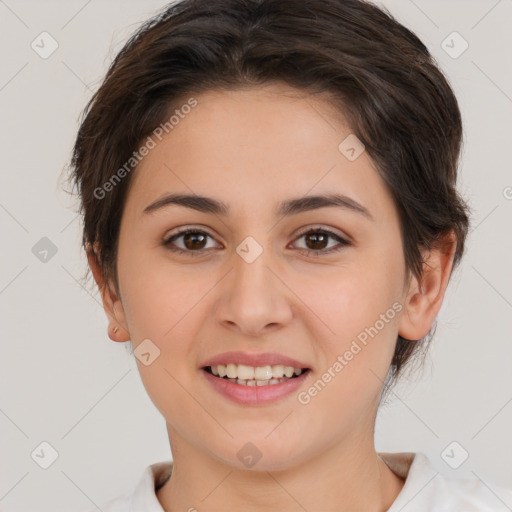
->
[90,85,438,470]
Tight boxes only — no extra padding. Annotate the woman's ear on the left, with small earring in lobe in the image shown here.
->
[87,242,130,342]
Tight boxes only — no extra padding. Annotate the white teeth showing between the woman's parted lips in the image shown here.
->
[210,363,302,386]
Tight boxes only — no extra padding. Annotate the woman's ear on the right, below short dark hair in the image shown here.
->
[398,232,457,340]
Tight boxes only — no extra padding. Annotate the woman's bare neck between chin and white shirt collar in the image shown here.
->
[157,429,404,512]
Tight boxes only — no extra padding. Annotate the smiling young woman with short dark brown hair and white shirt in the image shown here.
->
[72,0,512,512]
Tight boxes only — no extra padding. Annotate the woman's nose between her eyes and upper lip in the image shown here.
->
[216,243,293,336]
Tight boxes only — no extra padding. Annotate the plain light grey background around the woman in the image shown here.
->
[0,0,512,512]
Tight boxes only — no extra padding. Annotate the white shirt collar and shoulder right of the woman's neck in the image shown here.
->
[380,452,512,512]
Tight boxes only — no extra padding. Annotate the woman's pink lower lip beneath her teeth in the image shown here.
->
[201,369,310,405]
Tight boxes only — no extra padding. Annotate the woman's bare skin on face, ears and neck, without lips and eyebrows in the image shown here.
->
[89,84,454,512]
